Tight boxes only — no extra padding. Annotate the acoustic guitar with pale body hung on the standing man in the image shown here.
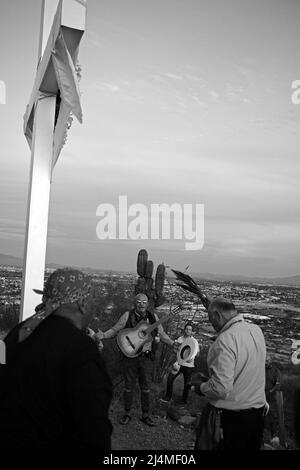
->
[117,306,181,358]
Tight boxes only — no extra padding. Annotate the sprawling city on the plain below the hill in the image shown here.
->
[0,266,300,364]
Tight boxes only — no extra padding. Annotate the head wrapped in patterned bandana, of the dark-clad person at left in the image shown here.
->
[35,268,94,329]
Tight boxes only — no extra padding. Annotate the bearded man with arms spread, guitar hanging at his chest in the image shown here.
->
[96,294,175,426]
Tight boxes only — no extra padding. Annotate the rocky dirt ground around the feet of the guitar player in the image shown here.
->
[110,377,295,450]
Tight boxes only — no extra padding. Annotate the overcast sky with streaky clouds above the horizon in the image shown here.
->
[0,0,300,277]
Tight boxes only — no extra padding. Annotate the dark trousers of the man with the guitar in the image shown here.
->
[123,356,153,415]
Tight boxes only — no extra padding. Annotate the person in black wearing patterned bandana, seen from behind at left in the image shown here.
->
[0,268,112,451]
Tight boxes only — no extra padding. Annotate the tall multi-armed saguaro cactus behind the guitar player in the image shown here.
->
[135,250,165,311]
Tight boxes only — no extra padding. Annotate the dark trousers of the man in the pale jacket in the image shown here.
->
[221,407,264,450]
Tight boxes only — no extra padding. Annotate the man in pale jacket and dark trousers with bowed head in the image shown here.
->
[196,297,266,450]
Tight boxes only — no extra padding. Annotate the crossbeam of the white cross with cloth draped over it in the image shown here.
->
[24,0,86,169]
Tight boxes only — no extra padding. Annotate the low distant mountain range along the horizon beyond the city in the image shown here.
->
[0,253,300,287]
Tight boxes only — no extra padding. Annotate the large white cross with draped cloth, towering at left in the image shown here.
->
[20,0,86,320]
